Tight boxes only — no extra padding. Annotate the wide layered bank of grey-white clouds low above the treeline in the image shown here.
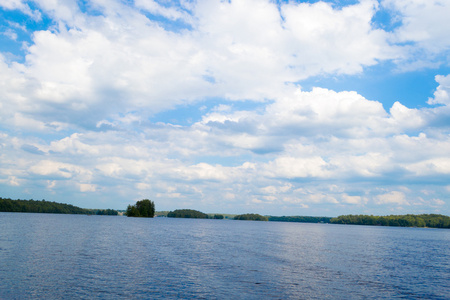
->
[2,76,450,213]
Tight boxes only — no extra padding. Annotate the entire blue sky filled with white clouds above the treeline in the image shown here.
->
[0,0,450,217]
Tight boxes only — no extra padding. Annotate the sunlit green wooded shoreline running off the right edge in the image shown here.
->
[330,214,450,228]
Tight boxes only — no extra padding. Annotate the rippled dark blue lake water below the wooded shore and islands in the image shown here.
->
[0,213,450,299]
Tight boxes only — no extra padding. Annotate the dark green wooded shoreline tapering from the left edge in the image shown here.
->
[0,198,118,215]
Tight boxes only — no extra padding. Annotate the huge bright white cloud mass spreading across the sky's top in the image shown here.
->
[0,1,400,126]
